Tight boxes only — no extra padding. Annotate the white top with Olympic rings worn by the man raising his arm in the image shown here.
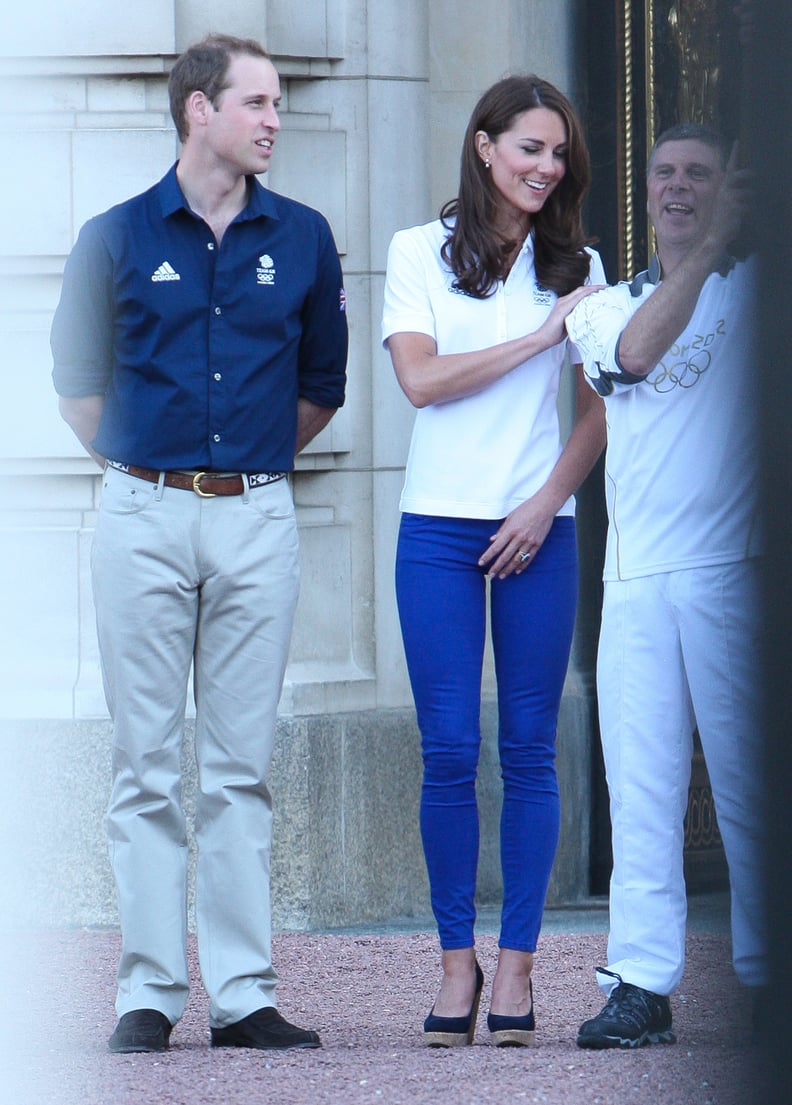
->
[567,259,761,580]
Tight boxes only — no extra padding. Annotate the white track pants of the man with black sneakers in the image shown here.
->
[598,561,767,995]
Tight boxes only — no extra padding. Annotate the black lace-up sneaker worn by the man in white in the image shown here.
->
[578,970,676,1048]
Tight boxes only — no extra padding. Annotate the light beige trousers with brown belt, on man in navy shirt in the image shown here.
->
[92,469,299,1027]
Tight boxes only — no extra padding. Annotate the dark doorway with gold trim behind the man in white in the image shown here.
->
[578,0,743,895]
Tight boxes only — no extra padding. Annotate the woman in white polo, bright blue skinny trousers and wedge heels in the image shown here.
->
[382,76,604,1046]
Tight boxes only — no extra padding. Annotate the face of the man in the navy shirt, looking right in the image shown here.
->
[205,54,281,176]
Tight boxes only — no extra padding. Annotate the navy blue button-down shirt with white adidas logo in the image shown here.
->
[51,167,347,472]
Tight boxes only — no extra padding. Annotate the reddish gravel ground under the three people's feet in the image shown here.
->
[0,930,760,1105]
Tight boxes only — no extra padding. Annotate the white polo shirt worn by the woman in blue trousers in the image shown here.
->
[382,220,605,518]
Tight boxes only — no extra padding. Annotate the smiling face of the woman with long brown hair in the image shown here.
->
[476,107,568,233]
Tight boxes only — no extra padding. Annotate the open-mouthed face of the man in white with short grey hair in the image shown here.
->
[646,138,724,252]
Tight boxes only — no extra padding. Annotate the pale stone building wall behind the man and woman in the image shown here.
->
[0,0,591,928]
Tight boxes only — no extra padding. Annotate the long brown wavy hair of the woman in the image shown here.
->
[440,74,590,299]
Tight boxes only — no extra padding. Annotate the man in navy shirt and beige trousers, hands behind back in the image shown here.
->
[52,35,347,1052]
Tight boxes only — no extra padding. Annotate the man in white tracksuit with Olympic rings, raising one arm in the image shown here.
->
[567,124,767,1048]
